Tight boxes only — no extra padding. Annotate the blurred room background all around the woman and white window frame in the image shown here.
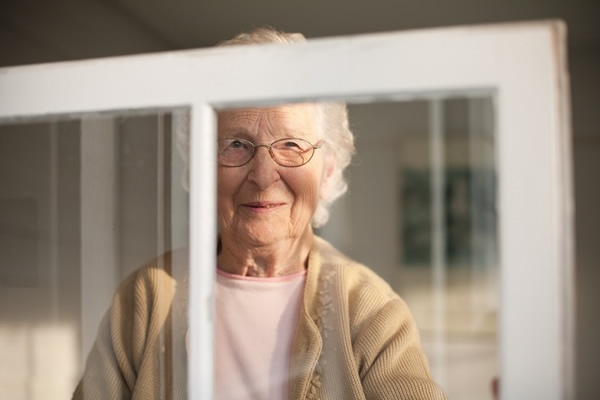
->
[0,0,600,400]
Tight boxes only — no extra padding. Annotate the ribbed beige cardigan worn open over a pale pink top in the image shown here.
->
[73,237,446,400]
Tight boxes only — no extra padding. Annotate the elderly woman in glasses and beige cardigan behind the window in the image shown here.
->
[74,28,445,400]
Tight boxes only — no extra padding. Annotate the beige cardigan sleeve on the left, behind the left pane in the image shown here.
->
[73,267,172,400]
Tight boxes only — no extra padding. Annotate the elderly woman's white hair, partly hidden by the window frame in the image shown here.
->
[174,27,355,228]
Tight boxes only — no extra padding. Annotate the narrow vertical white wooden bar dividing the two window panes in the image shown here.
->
[188,103,217,399]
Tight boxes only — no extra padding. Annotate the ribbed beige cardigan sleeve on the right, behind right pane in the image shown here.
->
[353,288,446,400]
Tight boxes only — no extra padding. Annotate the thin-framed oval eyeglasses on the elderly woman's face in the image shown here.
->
[217,138,323,167]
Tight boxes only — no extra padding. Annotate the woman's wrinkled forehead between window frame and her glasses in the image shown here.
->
[219,103,317,134]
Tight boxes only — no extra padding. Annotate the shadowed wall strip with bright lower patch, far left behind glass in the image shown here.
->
[0,122,81,399]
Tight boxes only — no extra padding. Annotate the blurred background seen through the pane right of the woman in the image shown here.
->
[319,97,499,400]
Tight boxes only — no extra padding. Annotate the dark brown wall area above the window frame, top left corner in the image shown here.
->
[0,0,174,65]
